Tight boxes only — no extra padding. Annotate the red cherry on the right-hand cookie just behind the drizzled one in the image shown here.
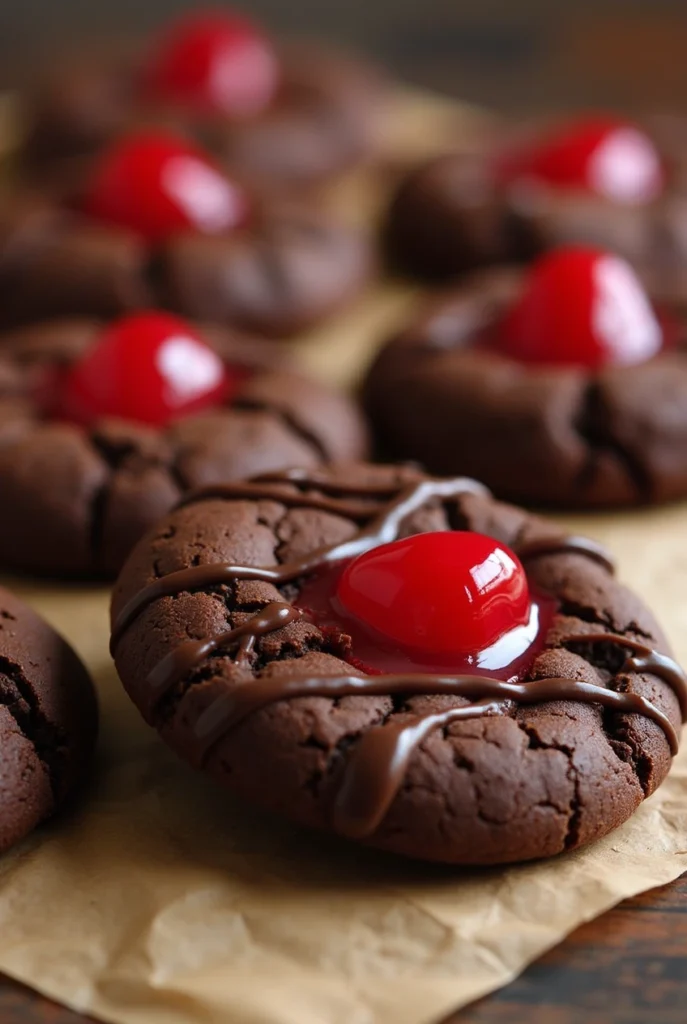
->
[497,247,663,369]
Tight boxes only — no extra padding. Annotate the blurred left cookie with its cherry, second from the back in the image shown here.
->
[0,130,372,337]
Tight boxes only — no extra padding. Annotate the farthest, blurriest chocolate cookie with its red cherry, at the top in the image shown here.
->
[22,10,387,190]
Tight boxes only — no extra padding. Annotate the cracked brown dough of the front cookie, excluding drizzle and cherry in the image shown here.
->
[113,464,681,864]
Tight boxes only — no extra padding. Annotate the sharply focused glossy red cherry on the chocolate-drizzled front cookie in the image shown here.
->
[337,531,531,665]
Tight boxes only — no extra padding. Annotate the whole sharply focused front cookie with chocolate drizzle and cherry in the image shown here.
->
[112,464,687,864]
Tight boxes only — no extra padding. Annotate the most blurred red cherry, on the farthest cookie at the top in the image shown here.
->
[146,11,280,118]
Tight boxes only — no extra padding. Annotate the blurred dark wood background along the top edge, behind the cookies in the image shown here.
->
[0,0,687,110]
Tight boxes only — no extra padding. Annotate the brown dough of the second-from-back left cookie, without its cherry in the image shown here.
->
[0,193,372,337]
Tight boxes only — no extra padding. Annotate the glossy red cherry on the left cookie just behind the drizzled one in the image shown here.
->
[57,312,237,426]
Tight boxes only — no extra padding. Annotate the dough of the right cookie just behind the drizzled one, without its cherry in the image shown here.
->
[363,262,687,508]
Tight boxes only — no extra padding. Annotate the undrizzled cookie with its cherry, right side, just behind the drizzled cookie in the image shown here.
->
[363,247,687,508]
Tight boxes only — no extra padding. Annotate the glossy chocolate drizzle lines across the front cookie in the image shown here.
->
[113,471,687,838]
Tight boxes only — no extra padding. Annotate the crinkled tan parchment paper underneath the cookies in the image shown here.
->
[0,92,687,1024]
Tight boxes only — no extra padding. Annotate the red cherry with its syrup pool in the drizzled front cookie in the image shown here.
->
[296,531,553,679]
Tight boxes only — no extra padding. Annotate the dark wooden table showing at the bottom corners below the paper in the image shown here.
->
[0,874,687,1024]
